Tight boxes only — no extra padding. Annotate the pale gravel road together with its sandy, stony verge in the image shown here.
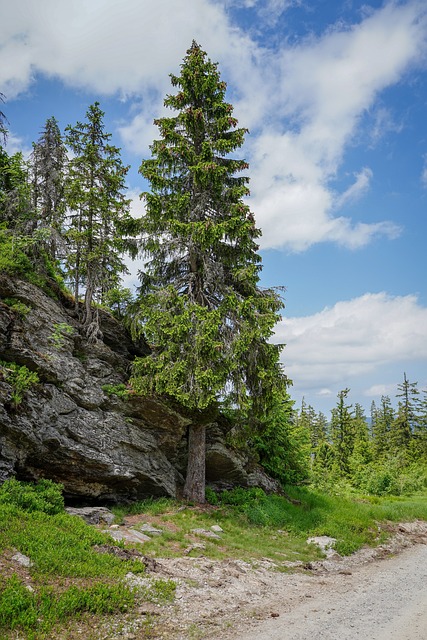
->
[115,521,427,640]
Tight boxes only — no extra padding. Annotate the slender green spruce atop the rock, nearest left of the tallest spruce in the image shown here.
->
[66,102,134,340]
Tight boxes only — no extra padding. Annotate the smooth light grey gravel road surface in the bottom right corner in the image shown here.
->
[234,544,427,640]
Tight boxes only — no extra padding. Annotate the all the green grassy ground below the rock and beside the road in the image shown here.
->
[0,481,427,640]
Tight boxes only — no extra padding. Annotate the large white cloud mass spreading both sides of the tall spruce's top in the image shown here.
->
[0,0,427,251]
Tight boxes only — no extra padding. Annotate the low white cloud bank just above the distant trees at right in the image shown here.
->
[276,293,427,393]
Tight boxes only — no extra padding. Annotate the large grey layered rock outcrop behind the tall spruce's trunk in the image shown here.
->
[0,275,274,503]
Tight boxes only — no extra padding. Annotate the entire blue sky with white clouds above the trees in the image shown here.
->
[0,0,427,417]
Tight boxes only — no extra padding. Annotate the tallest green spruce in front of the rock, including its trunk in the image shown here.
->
[133,42,284,502]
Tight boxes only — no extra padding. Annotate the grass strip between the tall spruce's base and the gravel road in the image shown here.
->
[111,487,427,562]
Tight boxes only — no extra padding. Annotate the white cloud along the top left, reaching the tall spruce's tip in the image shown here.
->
[0,0,231,99]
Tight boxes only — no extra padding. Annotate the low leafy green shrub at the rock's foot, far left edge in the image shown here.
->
[0,478,64,515]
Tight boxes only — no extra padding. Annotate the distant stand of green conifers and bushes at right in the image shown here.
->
[297,374,427,496]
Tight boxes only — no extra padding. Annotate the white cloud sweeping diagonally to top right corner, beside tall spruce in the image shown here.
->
[250,3,427,251]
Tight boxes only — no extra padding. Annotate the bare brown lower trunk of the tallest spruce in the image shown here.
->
[184,424,206,504]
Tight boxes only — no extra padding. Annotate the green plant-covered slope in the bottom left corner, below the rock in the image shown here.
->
[0,500,174,640]
